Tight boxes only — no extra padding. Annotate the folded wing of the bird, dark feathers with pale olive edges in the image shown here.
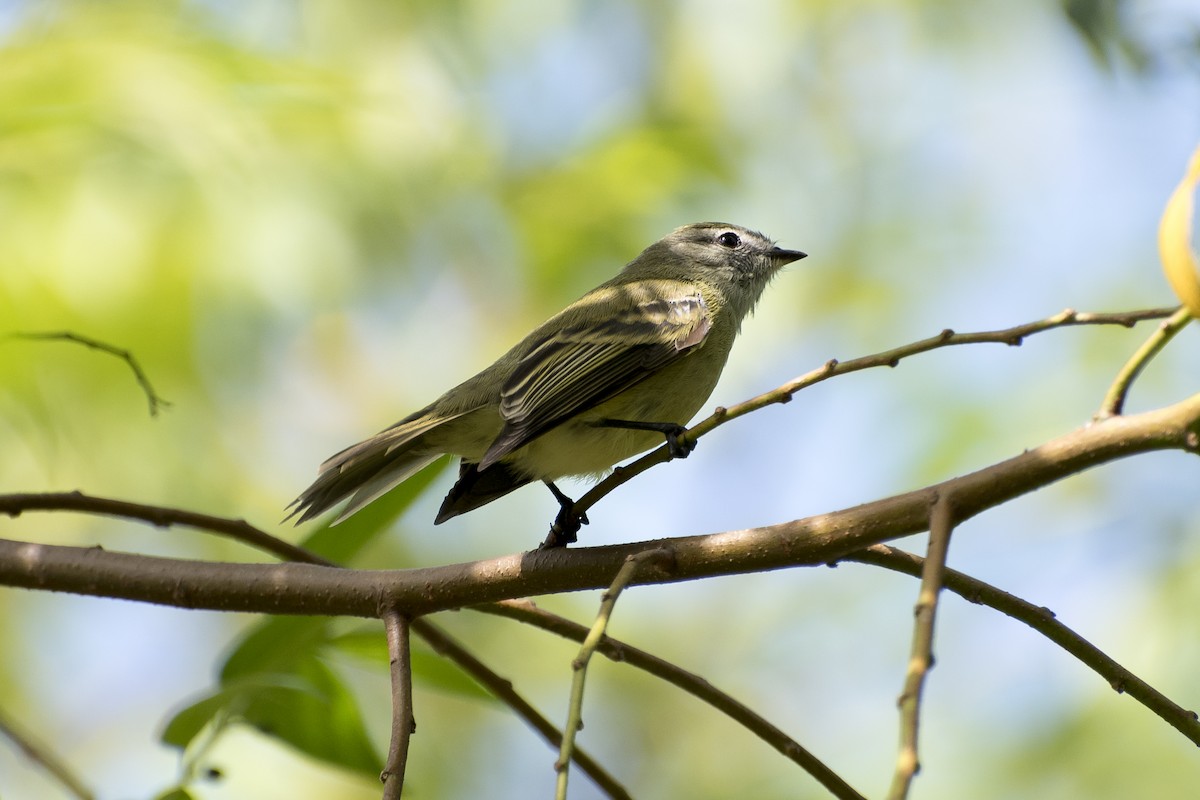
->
[479,284,712,470]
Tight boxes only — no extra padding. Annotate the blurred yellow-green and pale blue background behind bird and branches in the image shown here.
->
[0,0,1200,800]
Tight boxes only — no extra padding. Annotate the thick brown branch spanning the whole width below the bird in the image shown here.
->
[0,395,1200,616]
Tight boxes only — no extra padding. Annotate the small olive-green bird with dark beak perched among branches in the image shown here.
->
[289,222,805,546]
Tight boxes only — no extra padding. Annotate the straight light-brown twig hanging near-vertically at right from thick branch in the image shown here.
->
[888,494,954,800]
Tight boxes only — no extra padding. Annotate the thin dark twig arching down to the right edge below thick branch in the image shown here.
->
[841,545,1200,746]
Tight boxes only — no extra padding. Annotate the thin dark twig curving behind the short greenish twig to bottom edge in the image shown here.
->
[468,600,864,800]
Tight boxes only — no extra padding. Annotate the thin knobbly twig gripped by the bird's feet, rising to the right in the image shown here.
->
[572,308,1175,525]
